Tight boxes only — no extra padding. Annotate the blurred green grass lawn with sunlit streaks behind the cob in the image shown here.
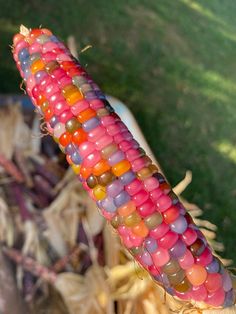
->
[0,0,236,262]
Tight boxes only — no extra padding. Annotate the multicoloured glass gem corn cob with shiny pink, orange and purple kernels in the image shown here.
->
[13,25,235,307]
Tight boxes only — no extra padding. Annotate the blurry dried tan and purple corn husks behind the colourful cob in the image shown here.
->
[0,104,231,314]
